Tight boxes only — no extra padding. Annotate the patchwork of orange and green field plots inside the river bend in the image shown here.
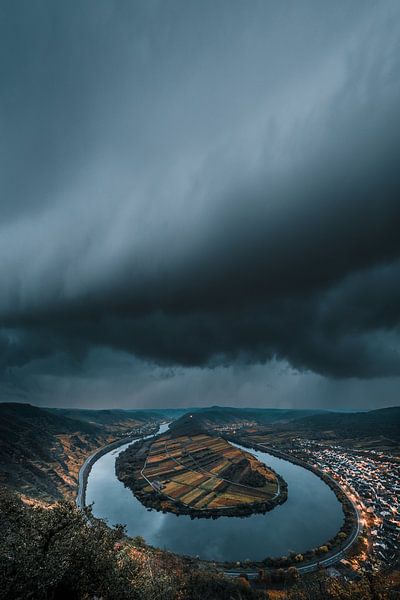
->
[142,434,278,510]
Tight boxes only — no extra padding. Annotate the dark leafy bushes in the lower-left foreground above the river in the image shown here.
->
[0,490,265,600]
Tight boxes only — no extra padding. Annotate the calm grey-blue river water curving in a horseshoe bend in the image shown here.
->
[86,425,343,560]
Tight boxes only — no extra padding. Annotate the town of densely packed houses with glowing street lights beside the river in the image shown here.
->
[290,439,400,567]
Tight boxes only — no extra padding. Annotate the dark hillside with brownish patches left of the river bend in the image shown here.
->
[0,403,161,501]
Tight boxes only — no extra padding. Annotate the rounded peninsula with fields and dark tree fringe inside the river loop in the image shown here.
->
[116,432,287,518]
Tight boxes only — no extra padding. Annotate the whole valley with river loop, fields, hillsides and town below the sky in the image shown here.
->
[0,403,400,597]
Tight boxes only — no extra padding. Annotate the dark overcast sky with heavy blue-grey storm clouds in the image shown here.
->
[0,0,400,408]
